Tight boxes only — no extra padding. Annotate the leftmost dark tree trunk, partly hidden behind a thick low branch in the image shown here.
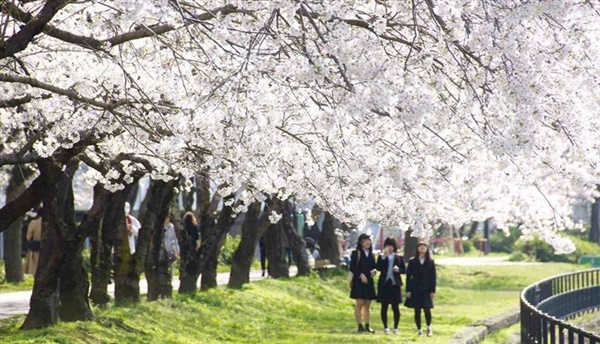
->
[4,166,33,283]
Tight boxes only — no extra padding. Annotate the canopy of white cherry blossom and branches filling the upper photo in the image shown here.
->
[0,0,600,320]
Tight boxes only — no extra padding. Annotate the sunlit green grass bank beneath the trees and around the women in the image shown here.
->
[0,264,579,344]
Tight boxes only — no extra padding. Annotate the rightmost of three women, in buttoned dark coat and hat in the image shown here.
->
[405,242,436,337]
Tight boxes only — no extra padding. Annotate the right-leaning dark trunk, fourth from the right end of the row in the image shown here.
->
[229,202,269,288]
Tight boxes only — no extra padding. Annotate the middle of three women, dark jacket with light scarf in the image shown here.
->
[377,237,406,334]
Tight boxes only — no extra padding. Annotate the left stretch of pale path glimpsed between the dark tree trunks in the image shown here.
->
[0,269,268,320]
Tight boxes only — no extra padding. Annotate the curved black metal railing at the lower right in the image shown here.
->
[521,269,600,344]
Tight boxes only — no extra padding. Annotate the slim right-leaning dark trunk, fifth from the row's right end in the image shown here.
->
[199,195,235,290]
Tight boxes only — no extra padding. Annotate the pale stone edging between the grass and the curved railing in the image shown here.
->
[450,309,520,344]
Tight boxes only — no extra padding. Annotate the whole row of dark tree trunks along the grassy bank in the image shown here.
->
[1,159,318,329]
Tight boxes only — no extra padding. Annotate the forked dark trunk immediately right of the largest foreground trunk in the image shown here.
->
[56,165,97,321]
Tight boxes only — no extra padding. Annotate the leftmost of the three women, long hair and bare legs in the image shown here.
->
[349,233,377,333]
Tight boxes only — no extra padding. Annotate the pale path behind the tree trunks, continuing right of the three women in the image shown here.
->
[0,257,520,319]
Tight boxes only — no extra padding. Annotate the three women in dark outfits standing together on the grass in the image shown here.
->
[349,234,436,336]
